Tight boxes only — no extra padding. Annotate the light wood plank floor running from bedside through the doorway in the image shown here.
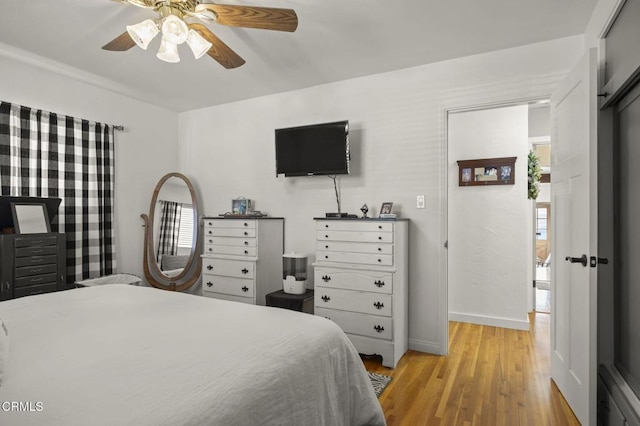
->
[364,313,580,426]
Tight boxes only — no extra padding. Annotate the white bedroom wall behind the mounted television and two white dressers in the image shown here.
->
[180,37,583,353]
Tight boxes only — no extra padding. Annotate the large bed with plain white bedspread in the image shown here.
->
[0,284,385,426]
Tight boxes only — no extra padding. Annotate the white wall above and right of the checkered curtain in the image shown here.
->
[0,50,179,282]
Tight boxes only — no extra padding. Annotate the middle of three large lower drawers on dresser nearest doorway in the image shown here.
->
[314,287,392,317]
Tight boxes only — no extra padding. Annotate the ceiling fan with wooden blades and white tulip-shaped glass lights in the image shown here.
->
[102,0,298,69]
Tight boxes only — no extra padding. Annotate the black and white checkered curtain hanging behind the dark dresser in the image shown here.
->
[0,102,116,283]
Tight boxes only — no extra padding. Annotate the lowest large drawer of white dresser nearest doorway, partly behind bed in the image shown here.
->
[314,307,393,340]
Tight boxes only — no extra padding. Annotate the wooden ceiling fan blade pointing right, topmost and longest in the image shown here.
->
[195,3,298,32]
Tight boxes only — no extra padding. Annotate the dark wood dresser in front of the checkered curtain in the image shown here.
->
[0,233,67,300]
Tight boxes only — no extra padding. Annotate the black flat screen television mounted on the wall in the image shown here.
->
[275,120,350,176]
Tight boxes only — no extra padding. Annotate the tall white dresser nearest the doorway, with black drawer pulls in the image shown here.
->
[313,218,409,368]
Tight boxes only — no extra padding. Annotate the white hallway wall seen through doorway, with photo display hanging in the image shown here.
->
[448,105,533,330]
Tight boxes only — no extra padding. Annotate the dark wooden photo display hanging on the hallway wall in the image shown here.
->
[458,157,517,186]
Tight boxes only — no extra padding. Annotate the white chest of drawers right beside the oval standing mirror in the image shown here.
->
[202,217,284,305]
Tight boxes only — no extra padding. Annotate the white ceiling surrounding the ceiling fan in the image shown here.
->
[0,0,596,112]
